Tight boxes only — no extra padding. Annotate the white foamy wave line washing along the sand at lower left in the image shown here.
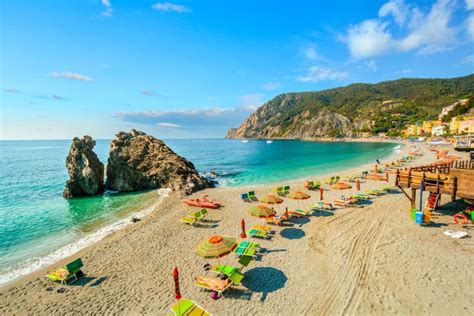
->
[0,189,171,284]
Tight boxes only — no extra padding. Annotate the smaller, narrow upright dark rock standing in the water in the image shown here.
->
[63,136,104,198]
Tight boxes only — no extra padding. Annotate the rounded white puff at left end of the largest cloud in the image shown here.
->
[344,20,393,58]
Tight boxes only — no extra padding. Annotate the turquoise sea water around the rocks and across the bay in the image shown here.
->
[0,139,398,283]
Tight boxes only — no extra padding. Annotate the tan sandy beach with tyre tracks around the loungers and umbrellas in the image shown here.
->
[0,142,474,315]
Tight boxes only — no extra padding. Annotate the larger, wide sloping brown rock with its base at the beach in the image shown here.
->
[106,129,213,194]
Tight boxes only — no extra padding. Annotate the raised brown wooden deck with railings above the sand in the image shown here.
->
[395,160,474,208]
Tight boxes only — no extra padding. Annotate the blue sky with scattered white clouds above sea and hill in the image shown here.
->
[0,0,474,140]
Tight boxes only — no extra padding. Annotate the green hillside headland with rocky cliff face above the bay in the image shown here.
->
[226,74,474,138]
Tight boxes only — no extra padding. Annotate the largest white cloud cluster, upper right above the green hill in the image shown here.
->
[342,0,457,58]
